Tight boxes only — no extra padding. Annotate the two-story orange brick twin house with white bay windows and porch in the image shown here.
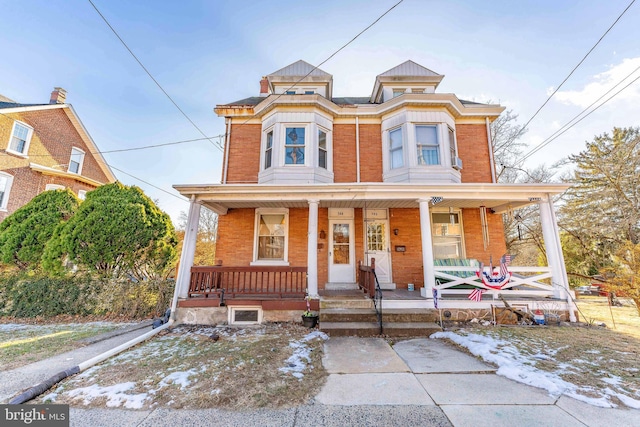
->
[174,61,573,325]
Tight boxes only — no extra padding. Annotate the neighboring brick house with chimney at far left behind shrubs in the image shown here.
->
[0,88,116,220]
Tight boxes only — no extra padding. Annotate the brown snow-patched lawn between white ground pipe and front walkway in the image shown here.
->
[37,324,327,409]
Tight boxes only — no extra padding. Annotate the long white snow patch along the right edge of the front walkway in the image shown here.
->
[431,332,640,409]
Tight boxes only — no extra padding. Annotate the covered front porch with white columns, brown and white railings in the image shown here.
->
[175,183,575,320]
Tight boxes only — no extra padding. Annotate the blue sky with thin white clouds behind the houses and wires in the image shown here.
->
[0,0,640,224]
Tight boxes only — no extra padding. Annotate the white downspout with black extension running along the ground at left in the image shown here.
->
[8,286,180,405]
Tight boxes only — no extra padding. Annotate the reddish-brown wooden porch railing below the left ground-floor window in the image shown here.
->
[189,266,307,299]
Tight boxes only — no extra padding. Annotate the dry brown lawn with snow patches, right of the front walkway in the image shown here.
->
[440,297,640,409]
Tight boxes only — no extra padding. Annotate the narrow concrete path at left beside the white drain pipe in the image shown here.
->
[0,322,151,403]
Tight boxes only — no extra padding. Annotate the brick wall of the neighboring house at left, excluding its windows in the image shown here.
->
[0,108,111,220]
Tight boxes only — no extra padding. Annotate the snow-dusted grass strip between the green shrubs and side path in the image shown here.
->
[0,322,127,371]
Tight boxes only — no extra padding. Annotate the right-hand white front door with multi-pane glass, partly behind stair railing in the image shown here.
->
[365,219,395,289]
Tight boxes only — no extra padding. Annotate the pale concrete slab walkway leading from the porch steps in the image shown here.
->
[316,338,640,427]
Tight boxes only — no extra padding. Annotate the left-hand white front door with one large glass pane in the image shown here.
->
[329,218,356,283]
